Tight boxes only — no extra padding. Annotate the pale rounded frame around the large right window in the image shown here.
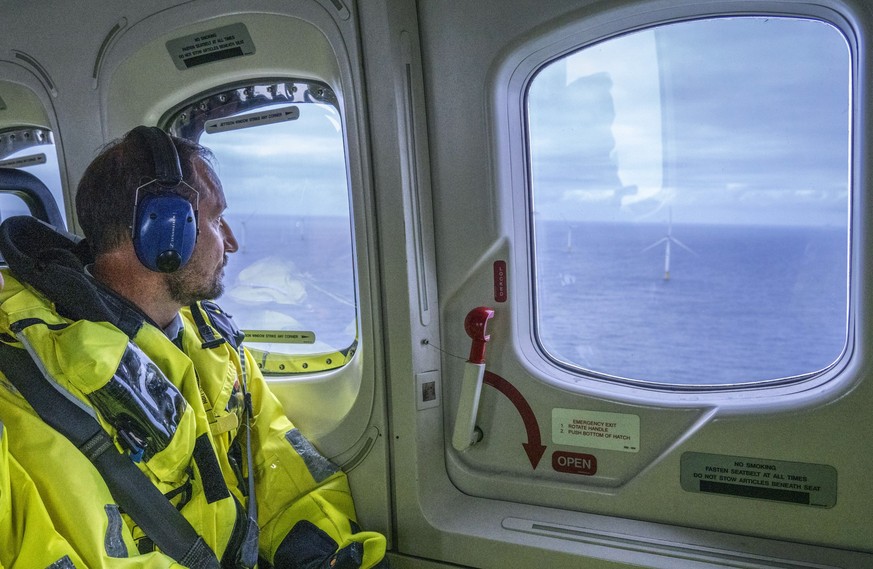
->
[491,1,871,408]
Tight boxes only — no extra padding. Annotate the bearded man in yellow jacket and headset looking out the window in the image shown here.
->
[0,127,385,569]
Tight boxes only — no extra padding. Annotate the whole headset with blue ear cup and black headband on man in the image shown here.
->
[131,126,199,273]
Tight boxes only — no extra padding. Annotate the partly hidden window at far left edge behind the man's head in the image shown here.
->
[0,126,64,221]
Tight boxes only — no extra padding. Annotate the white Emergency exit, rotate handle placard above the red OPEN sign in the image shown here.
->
[552,408,640,452]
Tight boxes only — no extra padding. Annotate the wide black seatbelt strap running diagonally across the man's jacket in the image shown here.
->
[0,343,220,569]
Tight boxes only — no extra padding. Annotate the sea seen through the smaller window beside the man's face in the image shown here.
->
[218,215,357,354]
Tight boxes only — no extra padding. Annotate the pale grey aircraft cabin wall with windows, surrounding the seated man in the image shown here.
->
[0,0,873,569]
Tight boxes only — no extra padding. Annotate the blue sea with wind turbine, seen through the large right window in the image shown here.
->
[534,221,848,385]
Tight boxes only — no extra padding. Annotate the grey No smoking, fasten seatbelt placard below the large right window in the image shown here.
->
[681,452,837,508]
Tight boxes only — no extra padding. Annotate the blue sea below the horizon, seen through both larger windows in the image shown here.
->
[219,216,848,386]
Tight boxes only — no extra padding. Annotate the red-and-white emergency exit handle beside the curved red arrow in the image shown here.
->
[452,306,494,452]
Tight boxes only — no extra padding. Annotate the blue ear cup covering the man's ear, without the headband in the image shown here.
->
[133,192,197,273]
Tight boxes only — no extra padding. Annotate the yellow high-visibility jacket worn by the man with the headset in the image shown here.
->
[0,271,385,569]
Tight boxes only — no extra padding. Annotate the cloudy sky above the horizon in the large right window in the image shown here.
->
[528,18,850,226]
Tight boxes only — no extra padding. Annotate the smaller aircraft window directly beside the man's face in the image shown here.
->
[170,81,358,375]
